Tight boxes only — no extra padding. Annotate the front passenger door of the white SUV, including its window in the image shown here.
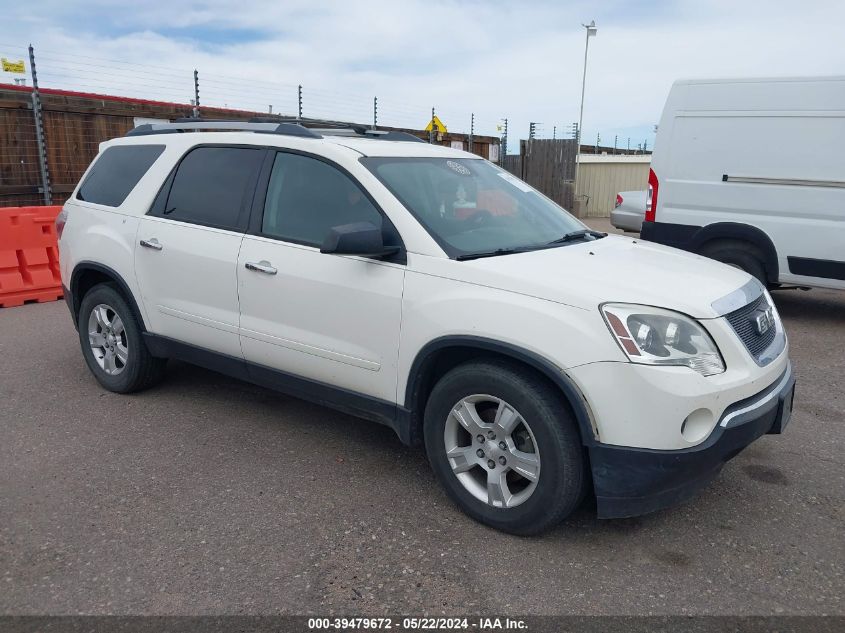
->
[238,152,405,403]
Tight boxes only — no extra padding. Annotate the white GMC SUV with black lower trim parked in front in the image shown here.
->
[57,122,794,534]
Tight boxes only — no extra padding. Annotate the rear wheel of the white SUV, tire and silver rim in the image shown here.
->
[78,284,167,393]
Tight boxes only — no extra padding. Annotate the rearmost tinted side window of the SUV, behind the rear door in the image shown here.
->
[76,145,164,207]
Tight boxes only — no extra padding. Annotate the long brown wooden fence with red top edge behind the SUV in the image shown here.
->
[0,85,499,206]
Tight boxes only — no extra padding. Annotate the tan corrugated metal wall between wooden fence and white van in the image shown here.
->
[578,154,651,218]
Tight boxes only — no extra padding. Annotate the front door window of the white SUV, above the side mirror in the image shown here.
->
[261,153,382,246]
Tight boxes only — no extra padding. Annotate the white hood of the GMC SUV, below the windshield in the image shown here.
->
[412,235,752,319]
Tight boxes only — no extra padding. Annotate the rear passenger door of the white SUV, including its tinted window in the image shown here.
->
[135,146,267,358]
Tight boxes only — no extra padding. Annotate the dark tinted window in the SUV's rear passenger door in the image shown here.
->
[161,147,264,229]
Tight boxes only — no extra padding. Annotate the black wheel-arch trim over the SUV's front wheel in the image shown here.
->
[400,335,597,446]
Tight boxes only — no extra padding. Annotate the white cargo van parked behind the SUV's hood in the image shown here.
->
[642,77,845,289]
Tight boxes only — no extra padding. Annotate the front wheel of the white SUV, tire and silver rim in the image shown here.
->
[424,360,587,536]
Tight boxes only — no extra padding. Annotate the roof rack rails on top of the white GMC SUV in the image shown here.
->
[126,117,425,143]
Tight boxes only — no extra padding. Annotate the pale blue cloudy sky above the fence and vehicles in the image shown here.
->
[0,0,845,151]
